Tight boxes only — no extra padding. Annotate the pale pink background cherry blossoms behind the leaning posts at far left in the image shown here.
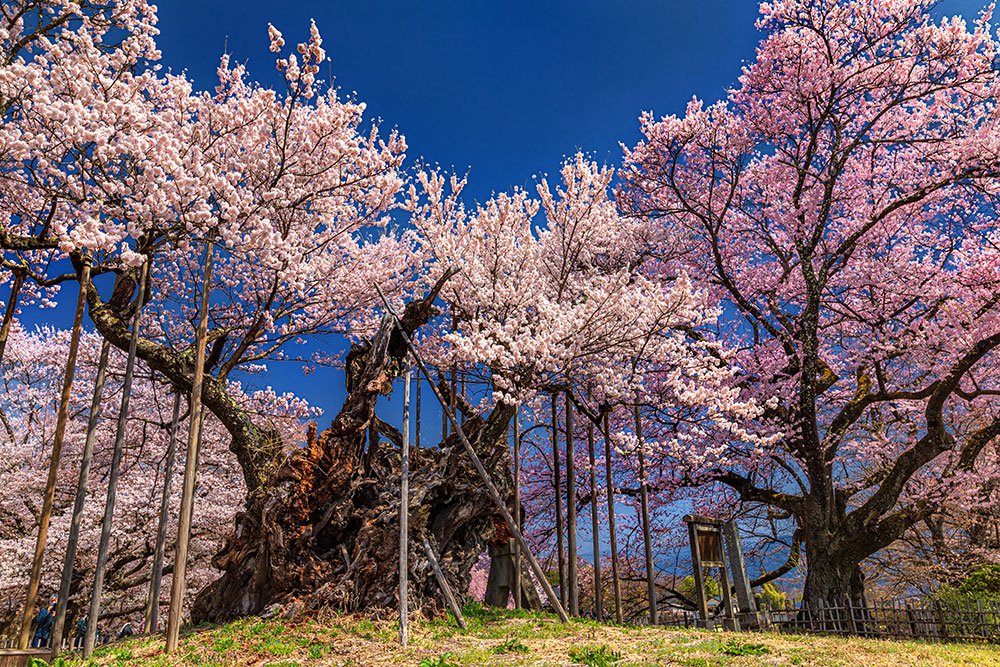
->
[0,327,318,636]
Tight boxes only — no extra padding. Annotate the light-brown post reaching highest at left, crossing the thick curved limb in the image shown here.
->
[166,239,214,653]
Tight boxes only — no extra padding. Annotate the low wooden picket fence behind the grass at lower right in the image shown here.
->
[659,600,1000,643]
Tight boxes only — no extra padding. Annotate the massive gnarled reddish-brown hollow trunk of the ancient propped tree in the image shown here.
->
[192,288,514,622]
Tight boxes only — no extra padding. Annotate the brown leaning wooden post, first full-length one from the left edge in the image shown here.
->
[18,259,90,649]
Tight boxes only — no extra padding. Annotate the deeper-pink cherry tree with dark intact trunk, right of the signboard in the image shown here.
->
[620,0,1000,602]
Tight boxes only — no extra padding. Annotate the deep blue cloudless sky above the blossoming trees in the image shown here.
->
[33,0,982,436]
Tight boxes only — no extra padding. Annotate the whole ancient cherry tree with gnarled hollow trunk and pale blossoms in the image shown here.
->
[0,0,757,618]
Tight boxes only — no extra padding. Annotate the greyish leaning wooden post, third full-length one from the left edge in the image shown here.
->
[83,262,149,658]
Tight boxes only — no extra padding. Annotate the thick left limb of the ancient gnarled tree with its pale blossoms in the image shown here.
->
[0,0,409,490]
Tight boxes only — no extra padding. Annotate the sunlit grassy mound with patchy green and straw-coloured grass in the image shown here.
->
[56,605,1000,667]
